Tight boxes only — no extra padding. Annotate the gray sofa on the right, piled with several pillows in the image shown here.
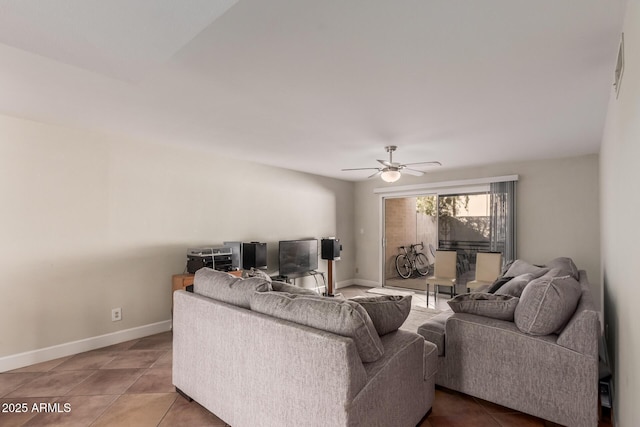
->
[418,260,600,427]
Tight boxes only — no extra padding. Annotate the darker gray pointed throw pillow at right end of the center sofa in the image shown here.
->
[351,295,411,335]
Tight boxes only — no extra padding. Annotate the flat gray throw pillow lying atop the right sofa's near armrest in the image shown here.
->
[447,292,518,321]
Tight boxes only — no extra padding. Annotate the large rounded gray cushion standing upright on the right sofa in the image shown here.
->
[515,269,582,335]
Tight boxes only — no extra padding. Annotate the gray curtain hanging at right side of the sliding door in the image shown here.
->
[489,181,517,263]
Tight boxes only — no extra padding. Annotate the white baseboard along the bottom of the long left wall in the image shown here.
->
[0,320,172,372]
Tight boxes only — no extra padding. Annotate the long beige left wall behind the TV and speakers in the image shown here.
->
[0,116,355,357]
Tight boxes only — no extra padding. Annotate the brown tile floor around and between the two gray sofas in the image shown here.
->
[0,286,611,427]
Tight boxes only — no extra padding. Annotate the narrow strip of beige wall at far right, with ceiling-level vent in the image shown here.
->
[600,0,640,427]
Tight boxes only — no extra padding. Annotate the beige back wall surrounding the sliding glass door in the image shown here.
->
[354,155,601,304]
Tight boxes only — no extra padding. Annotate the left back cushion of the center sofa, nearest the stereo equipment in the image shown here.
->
[193,268,271,308]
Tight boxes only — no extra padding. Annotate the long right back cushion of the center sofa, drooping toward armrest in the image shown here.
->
[251,292,384,362]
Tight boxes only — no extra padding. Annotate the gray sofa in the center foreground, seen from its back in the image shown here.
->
[173,269,436,427]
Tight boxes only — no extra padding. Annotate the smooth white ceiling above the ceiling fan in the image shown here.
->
[0,0,625,180]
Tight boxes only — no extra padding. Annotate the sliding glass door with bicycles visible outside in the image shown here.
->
[379,176,517,291]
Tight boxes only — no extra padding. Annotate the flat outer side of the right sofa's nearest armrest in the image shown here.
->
[439,313,598,426]
